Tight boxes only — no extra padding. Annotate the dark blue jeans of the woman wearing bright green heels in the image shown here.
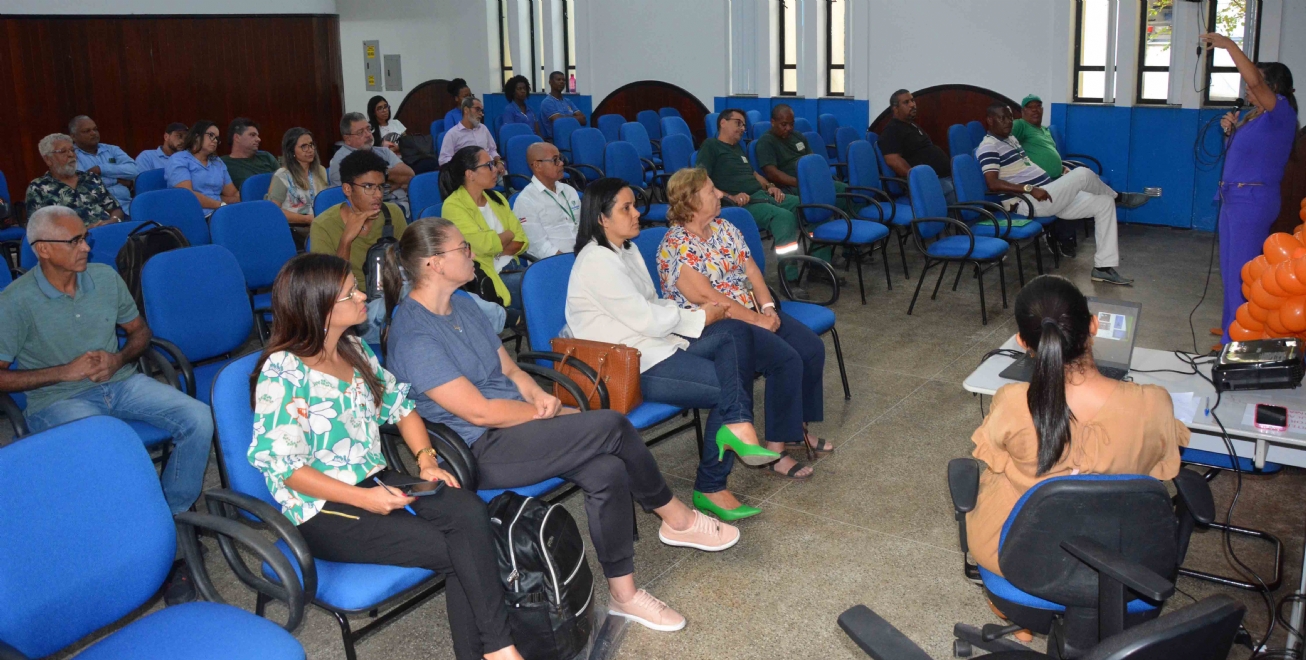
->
[640,320,752,493]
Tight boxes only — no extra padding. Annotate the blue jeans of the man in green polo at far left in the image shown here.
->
[26,374,213,514]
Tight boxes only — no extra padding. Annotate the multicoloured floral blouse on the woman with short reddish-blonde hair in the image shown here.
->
[657,218,757,310]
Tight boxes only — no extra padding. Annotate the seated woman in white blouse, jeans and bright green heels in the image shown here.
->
[564,178,780,521]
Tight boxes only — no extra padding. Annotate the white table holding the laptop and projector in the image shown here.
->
[961,335,1306,648]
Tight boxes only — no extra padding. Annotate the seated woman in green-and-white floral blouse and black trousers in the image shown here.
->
[248,254,521,660]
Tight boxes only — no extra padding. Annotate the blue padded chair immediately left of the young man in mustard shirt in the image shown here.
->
[209,200,295,340]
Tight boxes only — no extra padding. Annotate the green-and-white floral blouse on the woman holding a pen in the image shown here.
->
[247,340,414,525]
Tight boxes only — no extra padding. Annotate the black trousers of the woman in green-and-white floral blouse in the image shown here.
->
[299,469,512,660]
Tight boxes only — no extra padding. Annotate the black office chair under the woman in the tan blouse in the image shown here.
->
[948,459,1215,659]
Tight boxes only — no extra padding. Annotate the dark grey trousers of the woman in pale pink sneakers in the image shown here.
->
[471,410,671,578]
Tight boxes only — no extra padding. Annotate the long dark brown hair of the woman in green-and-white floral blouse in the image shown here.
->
[249,252,389,408]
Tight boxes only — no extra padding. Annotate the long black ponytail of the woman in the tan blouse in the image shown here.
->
[1016,274,1093,476]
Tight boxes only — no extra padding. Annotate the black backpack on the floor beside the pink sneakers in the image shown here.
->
[490,491,594,660]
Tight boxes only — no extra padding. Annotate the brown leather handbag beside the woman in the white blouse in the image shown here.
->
[550,337,644,414]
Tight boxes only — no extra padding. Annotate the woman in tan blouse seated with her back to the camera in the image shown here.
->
[966,276,1188,575]
